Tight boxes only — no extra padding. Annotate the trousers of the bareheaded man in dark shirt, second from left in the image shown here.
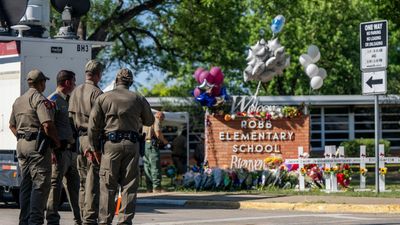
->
[46,150,82,225]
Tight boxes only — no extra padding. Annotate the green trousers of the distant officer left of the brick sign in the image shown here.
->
[143,142,161,190]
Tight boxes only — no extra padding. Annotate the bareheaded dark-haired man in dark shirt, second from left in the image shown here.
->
[46,70,82,225]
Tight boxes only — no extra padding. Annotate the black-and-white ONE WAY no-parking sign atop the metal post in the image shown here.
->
[360,20,388,71]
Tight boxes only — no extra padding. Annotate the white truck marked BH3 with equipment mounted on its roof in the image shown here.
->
[0,0,108,203]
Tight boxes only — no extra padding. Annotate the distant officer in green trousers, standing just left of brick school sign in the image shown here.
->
[143,112,168,193]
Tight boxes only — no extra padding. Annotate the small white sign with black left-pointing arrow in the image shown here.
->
[362,70,387,95]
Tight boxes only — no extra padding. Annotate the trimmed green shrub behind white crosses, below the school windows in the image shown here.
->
[340,138,390,157]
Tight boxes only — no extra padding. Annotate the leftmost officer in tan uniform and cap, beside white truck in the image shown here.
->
[10,69,60,225]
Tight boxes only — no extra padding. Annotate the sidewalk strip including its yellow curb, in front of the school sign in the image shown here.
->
[138,192,400,214]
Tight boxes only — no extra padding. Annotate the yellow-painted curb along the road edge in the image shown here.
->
[185,200,400,214]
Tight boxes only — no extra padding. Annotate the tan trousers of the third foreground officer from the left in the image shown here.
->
[77,136,100,225]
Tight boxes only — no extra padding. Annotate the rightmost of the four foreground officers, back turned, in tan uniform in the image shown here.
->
[89,69,154,224]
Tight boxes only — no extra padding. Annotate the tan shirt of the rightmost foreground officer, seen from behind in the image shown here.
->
[88,85,154,150]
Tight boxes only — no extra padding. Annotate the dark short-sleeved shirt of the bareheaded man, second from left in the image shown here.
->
[49,91,73,141]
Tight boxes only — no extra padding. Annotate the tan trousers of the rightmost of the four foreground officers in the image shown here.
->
[99,140,139,224]
